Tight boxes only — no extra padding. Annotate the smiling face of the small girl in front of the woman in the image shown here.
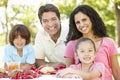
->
[76,41,95,64]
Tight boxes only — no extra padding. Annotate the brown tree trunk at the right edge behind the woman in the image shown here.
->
[114,2,120,47]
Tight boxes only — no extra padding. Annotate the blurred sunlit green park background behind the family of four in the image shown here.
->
[0,0,120,67]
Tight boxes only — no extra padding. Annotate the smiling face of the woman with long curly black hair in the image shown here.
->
[74,12,92,35]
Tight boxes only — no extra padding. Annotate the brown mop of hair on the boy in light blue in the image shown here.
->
[9,24,31,45]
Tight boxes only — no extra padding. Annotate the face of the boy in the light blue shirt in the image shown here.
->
[13,35,26,49]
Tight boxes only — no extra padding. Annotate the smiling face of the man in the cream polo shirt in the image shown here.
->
[42,11,60,36]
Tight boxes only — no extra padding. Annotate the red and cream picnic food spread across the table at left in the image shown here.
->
[0,64,66,79]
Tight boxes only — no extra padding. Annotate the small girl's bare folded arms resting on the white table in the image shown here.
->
[56,68,103,80]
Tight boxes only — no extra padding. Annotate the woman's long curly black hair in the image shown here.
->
[67,5,108,42]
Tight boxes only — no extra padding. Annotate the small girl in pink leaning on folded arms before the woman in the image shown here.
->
[57,38,105,80]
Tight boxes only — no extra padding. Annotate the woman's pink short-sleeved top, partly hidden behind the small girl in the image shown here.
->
[64,37,117,80]
